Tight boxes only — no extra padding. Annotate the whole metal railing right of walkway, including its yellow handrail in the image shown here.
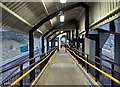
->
[67,47,120,87]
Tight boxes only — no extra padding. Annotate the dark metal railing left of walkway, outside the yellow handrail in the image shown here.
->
[0,48,55,87]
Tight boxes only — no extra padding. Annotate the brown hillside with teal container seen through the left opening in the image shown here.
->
[0,28,29,62]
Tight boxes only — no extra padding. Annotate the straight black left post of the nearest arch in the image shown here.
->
[29,32,35,83]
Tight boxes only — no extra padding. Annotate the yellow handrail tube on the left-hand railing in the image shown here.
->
[8,50,54,87]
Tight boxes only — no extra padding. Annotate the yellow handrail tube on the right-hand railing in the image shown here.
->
[69,49,120,84]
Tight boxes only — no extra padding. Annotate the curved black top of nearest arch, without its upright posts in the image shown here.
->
[29,2,89,33]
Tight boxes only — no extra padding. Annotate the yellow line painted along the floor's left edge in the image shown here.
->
[30,51,57,87]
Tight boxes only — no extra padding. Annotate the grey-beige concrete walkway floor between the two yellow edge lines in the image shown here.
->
[37,50,91,86]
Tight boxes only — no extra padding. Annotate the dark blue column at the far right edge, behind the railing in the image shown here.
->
[113,19,120,87]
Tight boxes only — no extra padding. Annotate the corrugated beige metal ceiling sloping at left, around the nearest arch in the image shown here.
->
[2,2,83,36]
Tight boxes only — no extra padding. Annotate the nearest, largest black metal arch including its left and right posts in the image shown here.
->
[29,2,89,82]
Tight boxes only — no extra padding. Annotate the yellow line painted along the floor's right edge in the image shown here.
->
[67,51,100,87]
